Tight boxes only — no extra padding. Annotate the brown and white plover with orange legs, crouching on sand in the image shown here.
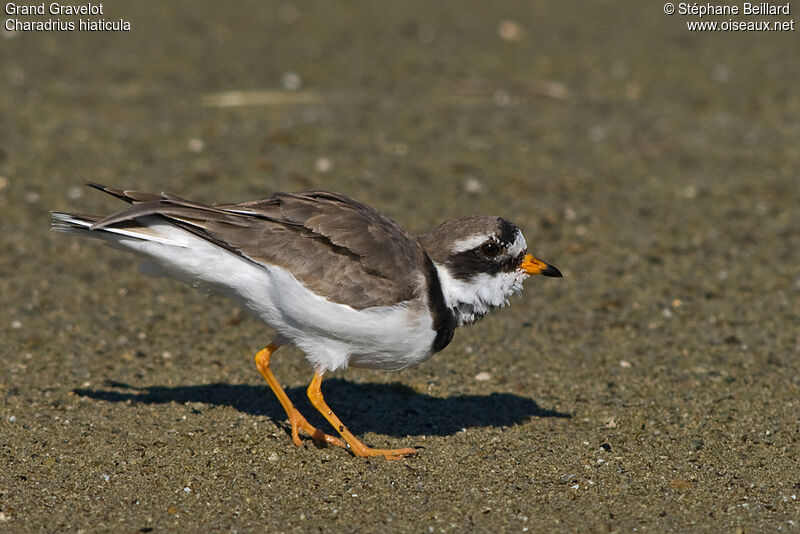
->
[51,182,562,460]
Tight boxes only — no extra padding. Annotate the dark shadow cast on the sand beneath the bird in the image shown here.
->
[73,378,571,437]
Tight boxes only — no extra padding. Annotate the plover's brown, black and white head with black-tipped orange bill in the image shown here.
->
[419,216,561,325]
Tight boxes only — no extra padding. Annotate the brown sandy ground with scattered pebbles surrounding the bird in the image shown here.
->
[0,0,800,532]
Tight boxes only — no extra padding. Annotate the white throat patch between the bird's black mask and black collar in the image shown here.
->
[434,262,528,326]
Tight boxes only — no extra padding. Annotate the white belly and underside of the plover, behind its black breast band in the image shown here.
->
[108,219,436,371]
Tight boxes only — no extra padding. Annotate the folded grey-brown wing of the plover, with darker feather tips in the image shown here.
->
[85,184,427,309]
